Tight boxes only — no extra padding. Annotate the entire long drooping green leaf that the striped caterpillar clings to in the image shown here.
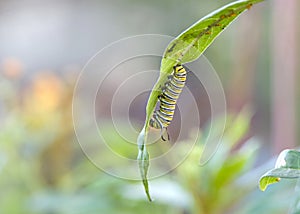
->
[138,0,263,200]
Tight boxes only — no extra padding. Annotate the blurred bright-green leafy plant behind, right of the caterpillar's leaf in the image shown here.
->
[177,109,258,214]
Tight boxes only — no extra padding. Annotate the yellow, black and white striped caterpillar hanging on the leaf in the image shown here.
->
[149,65,187,141]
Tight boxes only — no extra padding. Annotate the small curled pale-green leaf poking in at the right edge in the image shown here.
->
[259,150,300,191]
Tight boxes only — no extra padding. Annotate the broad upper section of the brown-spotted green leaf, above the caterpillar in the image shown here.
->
[162,0,263,67]
